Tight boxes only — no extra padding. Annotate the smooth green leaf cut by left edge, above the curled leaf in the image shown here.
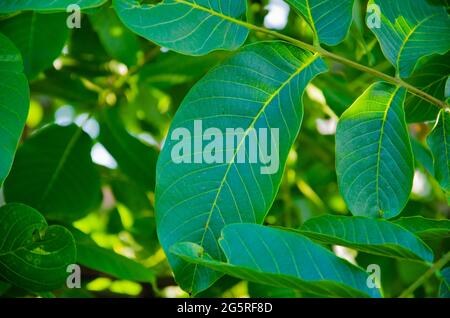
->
[0,33,30,187]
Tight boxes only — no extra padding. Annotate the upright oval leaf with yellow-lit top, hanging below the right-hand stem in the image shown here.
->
[336,82,414,218]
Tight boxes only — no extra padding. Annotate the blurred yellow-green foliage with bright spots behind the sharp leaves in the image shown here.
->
[0,0,450,297]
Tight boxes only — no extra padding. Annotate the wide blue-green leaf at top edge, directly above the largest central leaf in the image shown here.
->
[113,0,248,55]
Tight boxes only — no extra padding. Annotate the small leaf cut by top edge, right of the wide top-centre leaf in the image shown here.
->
[287,0,353,45]
